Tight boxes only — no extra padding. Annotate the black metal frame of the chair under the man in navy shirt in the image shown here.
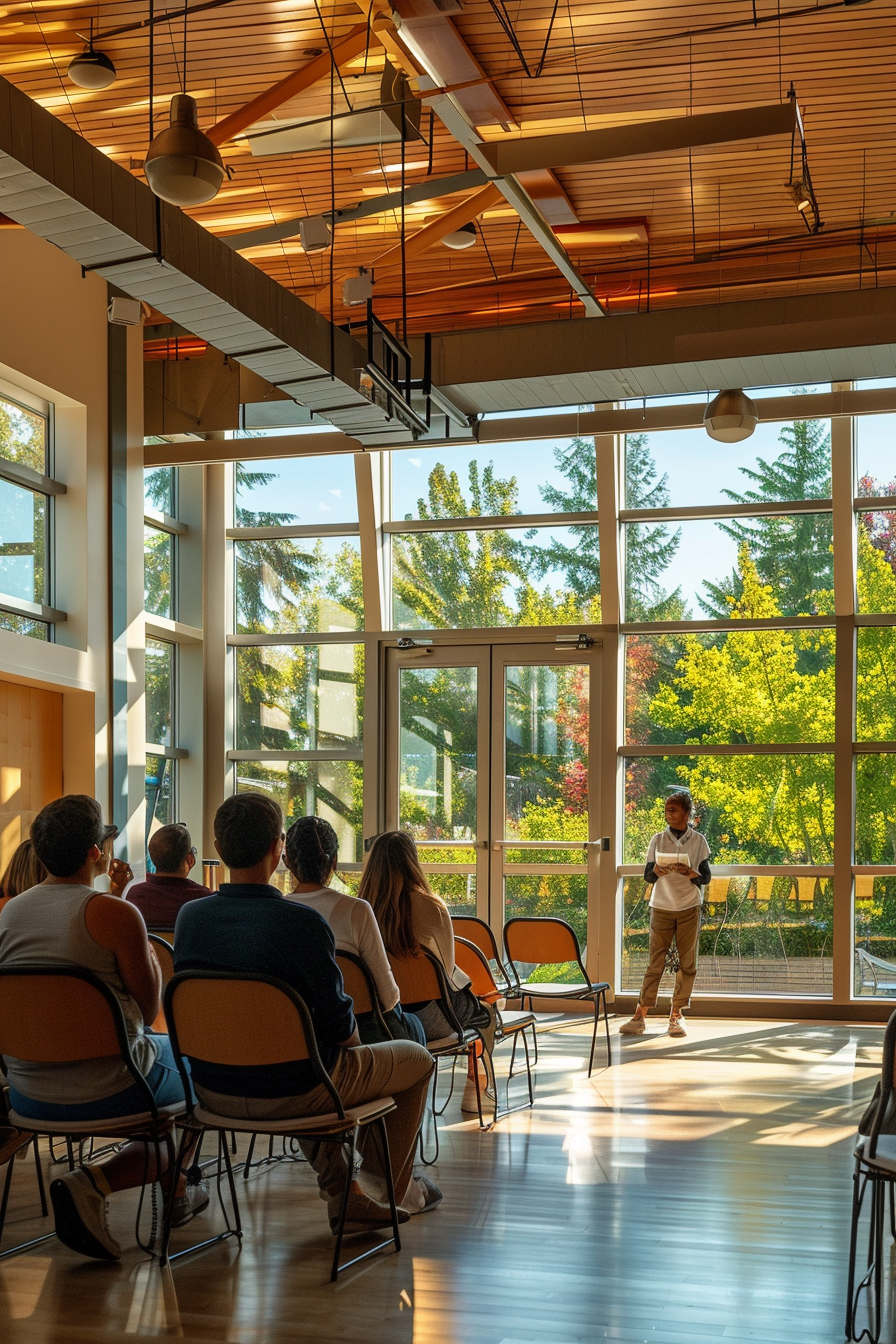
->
[161,970,402,1282]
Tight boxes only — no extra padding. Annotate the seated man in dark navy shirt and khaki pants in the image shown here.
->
[175,793,442,1232]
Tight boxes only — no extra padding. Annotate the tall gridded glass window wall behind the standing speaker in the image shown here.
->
[217,388,896,1001]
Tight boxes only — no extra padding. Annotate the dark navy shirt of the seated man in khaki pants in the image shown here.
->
[175,883,355,1097]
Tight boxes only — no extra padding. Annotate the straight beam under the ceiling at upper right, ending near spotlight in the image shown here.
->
[481,98,797,177]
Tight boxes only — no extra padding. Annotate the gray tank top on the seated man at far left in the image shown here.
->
[0,883,156,1106]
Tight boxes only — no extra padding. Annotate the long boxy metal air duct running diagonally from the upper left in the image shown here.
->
[0,77,429,446]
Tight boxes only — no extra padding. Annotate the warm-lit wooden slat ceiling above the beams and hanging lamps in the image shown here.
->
[0,0,896,333]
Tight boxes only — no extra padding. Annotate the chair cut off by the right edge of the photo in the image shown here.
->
[846,1012,896,1344]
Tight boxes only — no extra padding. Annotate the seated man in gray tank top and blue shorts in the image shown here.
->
[0,793,208,1259]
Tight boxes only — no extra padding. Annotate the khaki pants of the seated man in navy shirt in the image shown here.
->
[196,1040,435,1204]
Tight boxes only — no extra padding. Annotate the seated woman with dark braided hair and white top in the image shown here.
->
[283,817,426,1046]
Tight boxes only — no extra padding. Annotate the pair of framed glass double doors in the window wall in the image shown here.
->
[386,644,600,967]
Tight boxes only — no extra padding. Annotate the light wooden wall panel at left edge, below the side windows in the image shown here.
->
[0,679,63,872]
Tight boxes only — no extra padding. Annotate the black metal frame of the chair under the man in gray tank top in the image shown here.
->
[0,962,185,1258]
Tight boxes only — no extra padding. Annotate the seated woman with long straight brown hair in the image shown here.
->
[357,831,493,1040]
